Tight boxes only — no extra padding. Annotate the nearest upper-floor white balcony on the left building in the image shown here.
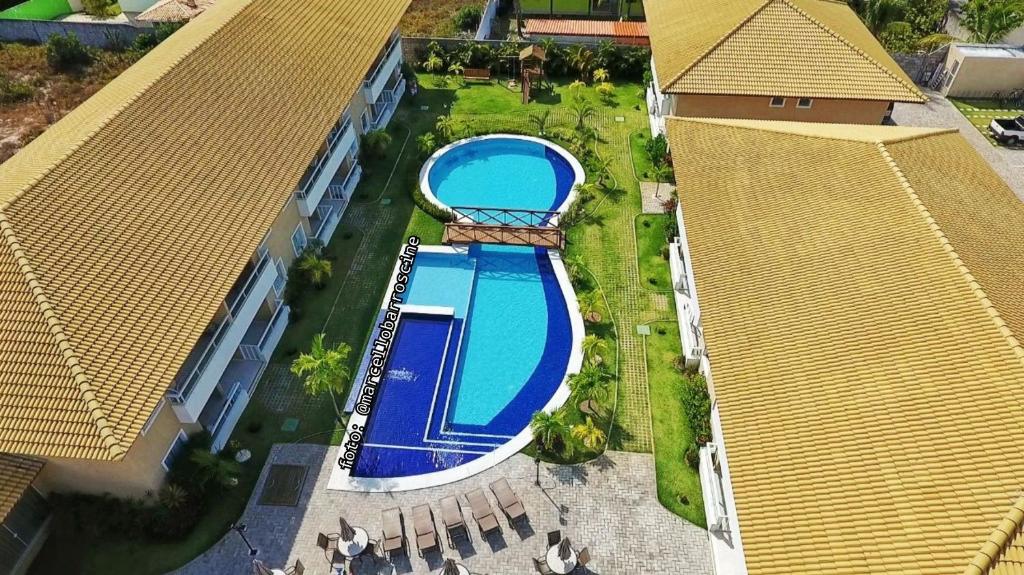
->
[168,253,279,424]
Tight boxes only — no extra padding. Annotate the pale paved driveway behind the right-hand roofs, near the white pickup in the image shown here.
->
[893,91,1024,202]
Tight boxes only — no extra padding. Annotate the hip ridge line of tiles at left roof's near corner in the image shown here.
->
[0,211,127,459]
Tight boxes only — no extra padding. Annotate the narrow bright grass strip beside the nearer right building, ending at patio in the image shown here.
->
[645,321,707,527]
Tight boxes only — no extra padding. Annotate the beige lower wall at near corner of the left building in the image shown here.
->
[36,401,201,497]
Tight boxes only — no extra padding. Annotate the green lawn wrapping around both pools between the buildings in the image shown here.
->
[33,76,702,575]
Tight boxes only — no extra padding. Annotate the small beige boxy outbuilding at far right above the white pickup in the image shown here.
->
[942,45,1024,98]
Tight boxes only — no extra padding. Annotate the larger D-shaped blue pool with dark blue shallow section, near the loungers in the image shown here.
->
[351,245,573,478]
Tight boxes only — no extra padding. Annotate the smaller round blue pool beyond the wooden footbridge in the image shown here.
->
[420,134,587,213]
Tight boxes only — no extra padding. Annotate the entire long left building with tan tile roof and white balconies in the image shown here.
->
[0,0,408,521]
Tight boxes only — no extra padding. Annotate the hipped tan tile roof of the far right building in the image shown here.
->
[644,0,925,102]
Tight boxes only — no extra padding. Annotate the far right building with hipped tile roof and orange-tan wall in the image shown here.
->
[644,0,925,130]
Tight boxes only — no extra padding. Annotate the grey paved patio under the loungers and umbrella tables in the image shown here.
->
[177,444,712,575]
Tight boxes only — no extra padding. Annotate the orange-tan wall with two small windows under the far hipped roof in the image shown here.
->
[673,94,889,124]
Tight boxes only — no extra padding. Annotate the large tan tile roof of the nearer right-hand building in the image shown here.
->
[669,119,1024,575]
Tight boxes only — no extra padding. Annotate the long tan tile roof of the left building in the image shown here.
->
[0,0,408,459]
